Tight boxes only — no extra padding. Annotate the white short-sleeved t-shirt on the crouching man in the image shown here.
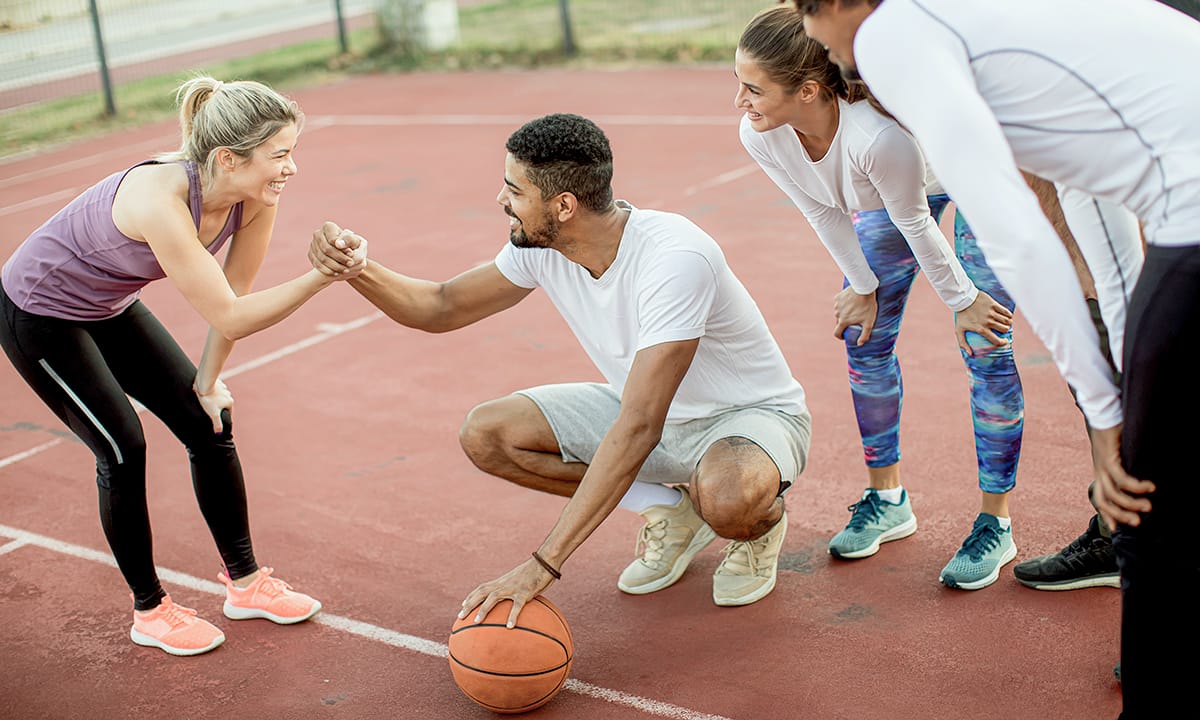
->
[496,202,806,424]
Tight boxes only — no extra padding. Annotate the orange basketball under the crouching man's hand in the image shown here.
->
[449,595,575,714]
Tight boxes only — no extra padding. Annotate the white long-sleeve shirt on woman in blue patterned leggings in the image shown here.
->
[740,100,979,312]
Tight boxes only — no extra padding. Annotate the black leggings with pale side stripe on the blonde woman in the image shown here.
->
[0,292,258,610]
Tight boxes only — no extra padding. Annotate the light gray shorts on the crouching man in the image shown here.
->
[517,383,810,493]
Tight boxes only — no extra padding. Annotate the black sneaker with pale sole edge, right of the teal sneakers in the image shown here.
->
[1013,515,1121,590]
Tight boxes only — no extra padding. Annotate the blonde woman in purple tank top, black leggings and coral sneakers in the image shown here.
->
[0,77,366,655]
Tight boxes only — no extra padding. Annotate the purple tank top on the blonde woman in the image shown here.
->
[0,160,242,320]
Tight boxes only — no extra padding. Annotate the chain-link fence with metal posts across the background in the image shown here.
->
[0,0,775,121]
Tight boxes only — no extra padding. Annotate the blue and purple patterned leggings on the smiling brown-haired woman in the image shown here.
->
[842,196,1025,493]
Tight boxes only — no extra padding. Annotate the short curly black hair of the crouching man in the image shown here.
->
[504,113,612,212]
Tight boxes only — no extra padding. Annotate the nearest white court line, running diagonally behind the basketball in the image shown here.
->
[0,524,730,720]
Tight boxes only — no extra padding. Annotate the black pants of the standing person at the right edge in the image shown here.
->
[1114,246,1200,720]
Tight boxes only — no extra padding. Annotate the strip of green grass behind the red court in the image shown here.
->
[0,0,764,158]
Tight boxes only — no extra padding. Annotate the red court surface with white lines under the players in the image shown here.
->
[0,67,1120,720]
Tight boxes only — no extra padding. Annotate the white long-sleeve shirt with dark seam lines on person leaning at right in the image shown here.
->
[854,0,1200,428]
